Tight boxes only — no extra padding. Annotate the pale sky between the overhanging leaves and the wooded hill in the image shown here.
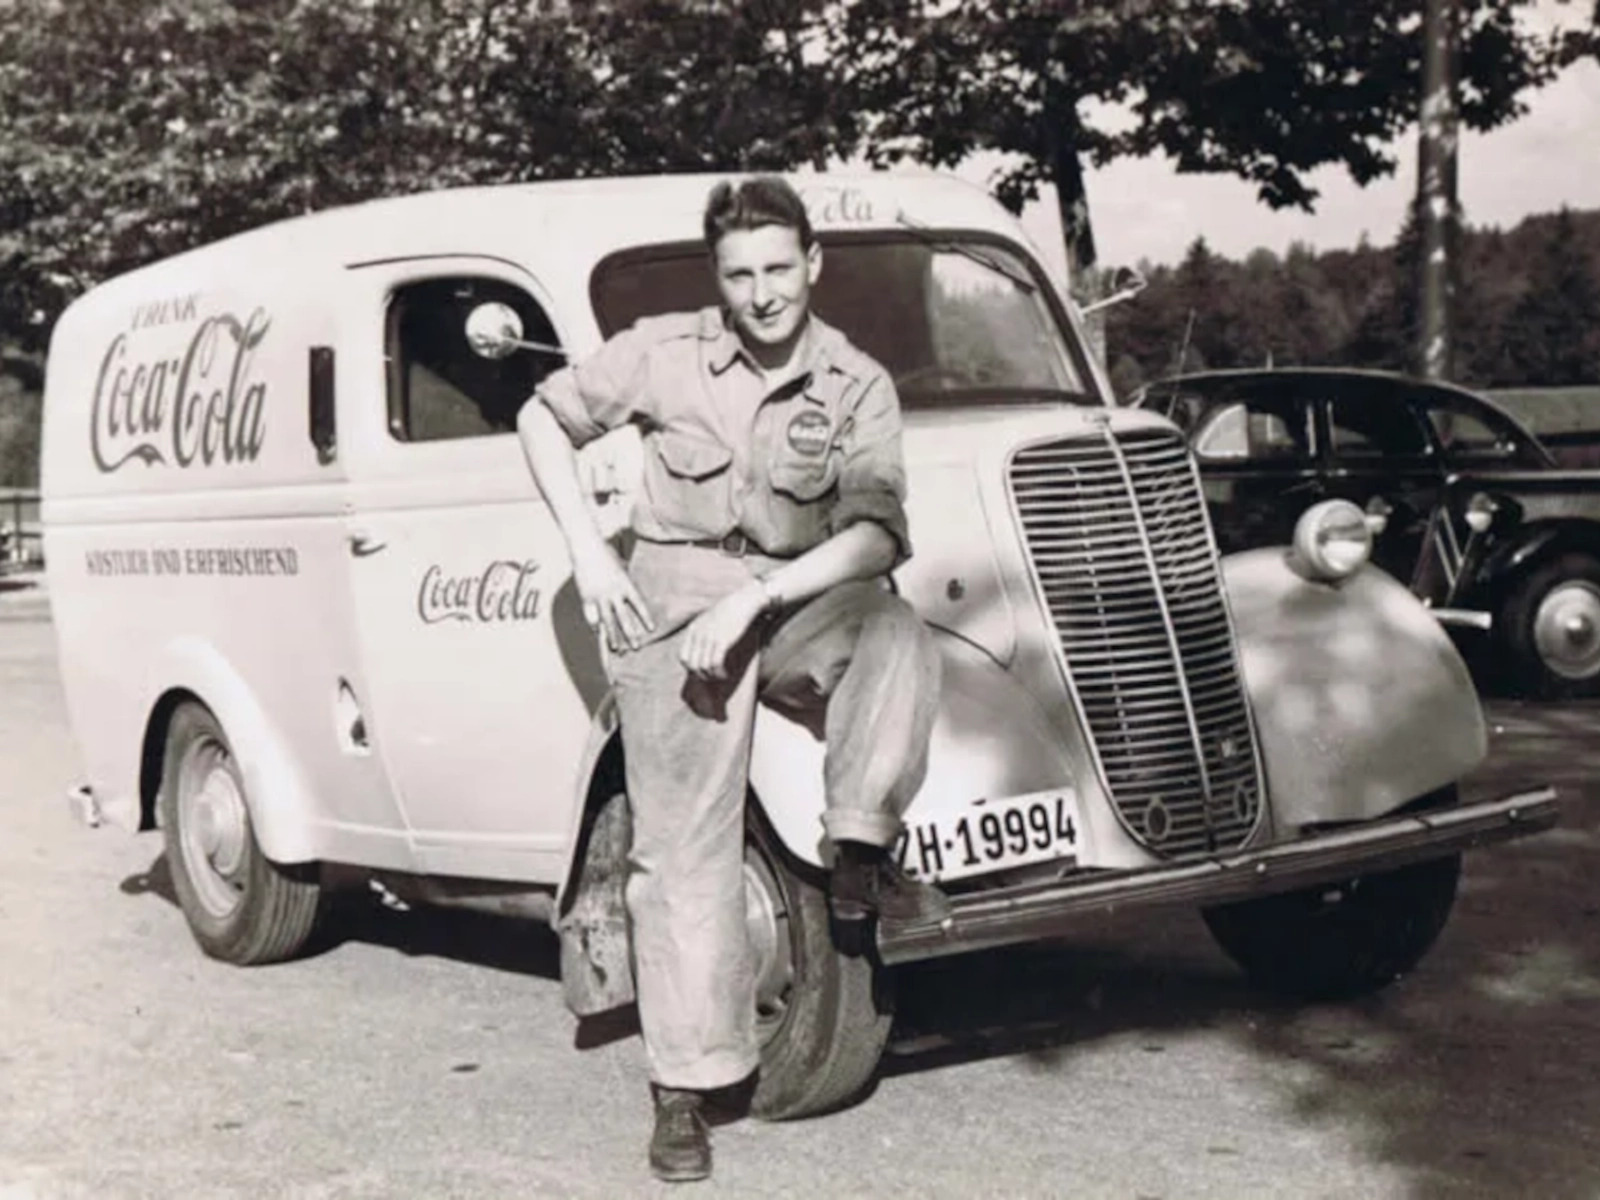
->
[1085,59,1600,267]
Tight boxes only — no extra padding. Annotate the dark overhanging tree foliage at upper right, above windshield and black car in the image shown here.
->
[837,0,1576,243]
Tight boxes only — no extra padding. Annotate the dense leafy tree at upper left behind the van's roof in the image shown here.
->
[0,0,856,354]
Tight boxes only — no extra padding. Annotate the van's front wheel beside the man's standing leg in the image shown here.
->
[744,811,893,1120]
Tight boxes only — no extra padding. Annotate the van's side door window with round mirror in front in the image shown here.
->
[384,275,563,442]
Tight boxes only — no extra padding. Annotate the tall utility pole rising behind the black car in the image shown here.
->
[1416,0,1458,379]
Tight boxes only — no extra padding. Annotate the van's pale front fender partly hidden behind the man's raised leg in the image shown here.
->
[750,629,1080,866]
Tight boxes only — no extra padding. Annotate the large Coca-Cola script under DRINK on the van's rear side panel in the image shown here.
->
[90,309,272,474]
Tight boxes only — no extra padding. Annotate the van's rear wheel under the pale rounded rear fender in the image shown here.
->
[157,702,322,965]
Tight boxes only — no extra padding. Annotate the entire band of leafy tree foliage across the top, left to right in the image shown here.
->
[0,0,1595,486]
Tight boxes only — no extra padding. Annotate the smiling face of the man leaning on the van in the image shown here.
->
[714,226,822,347]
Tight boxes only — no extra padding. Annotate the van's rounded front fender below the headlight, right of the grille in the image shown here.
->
[1222,549,1488,830]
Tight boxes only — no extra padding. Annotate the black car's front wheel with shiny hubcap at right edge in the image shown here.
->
[1499,550,1600,699]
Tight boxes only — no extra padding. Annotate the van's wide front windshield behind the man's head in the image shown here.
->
[592,230,1099,410]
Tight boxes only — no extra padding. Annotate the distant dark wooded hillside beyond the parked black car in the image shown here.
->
[1107,210,1600,394]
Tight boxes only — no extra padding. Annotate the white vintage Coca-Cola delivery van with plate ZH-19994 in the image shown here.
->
[43,174,1555,1115]
